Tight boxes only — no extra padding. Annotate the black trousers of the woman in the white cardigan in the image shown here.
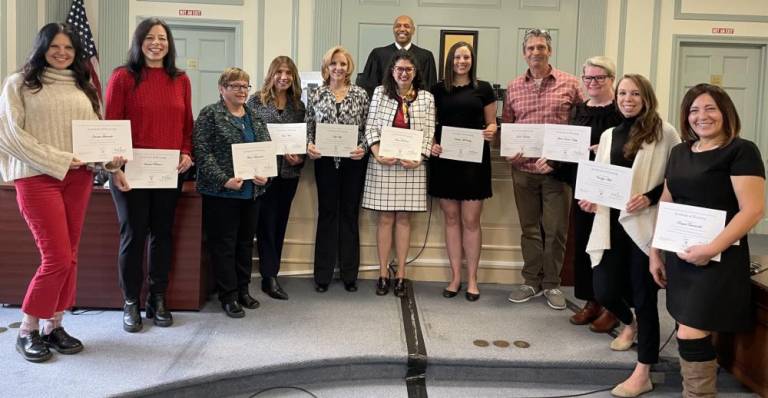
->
[592,209,660,364]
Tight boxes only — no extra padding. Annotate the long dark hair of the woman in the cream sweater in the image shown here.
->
[20,22,101,115]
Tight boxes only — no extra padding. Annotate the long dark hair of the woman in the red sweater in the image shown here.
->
[122,18,184,87]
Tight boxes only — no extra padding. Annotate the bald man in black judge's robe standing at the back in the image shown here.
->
[356,15,437,97]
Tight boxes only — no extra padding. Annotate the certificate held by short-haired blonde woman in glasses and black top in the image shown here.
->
[541,124,592,163]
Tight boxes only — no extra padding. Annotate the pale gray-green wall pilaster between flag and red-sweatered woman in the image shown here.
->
[98,0,133,96]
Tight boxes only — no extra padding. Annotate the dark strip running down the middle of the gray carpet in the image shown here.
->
[400,280,427,398]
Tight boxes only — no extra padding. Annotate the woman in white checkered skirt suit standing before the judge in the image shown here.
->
[363,51,435,297]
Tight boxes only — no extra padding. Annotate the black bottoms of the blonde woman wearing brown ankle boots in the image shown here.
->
[572,199,595,301]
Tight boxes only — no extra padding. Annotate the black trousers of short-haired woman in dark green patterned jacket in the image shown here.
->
[203,195,261,302]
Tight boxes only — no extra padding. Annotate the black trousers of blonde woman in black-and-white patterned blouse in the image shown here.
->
[315,156,368,284]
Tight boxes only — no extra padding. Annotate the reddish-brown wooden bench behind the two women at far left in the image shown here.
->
[0,182,208,310]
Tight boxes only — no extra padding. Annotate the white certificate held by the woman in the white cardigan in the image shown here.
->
[574,161,632,210]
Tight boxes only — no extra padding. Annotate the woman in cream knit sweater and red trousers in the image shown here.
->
[0,23,124,362]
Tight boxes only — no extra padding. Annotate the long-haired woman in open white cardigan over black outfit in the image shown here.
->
[579,74,680,397]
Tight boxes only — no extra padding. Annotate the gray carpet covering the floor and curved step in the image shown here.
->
[0,278,756,398]
